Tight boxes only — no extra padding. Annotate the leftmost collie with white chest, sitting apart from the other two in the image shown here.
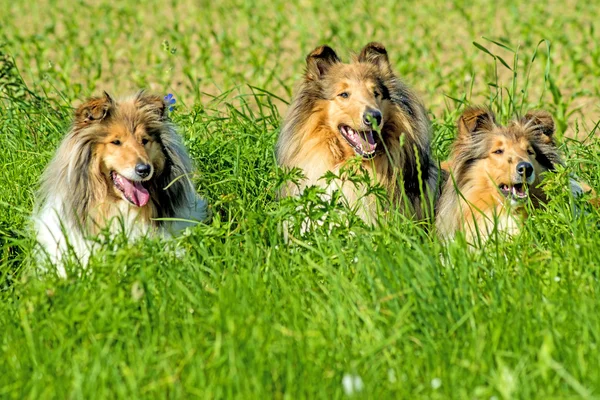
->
[33,92,207,276]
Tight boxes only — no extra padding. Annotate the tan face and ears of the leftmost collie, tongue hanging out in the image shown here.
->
[76,93,166,207]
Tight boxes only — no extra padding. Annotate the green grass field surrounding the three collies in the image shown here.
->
[0,0,600,399]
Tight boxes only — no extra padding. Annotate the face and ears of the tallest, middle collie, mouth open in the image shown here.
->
[306,43,398,159]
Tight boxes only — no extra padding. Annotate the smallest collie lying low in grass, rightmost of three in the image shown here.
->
[436,108,582,243]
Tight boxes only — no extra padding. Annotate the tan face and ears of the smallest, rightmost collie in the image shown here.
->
[459,109,556,205]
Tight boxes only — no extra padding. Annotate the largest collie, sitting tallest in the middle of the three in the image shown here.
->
[276,43,437,223]
